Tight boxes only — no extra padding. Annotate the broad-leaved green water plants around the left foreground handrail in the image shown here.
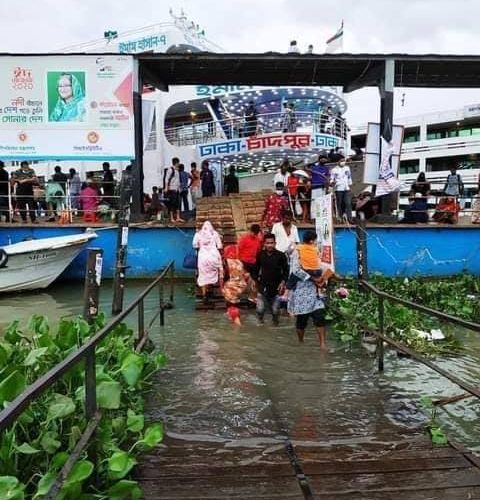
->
[0,315,167,500]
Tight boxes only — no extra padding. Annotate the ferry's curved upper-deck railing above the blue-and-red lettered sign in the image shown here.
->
[164,111,347,146]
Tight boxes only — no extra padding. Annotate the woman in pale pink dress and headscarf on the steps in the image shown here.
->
[192,221,223,301]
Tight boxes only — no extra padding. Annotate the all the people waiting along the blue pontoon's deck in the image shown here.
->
[0,152,480,227]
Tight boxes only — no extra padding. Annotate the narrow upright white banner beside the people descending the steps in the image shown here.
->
[312,193,335,272]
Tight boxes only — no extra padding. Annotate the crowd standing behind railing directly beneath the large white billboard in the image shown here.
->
[0,161,119,224]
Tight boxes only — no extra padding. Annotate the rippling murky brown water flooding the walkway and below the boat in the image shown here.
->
[0,281,480,448]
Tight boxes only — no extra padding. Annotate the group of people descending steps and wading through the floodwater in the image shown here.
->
[192,213,333,349]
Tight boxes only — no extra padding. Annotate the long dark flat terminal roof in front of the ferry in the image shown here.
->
[137,52,480,92]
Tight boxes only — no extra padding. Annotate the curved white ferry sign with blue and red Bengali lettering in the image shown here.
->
[197,133,339,159]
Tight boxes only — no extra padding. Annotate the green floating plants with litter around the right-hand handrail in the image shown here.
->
[330,275,480,356]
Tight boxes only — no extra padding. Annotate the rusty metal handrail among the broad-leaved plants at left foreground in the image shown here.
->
[0,261,175,499]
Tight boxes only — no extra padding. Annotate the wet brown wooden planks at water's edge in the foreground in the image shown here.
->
[137,434,480,500]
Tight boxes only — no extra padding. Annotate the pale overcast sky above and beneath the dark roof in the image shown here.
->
[0,0,480,125]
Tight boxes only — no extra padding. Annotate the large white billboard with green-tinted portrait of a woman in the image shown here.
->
[0,55,134,160]
